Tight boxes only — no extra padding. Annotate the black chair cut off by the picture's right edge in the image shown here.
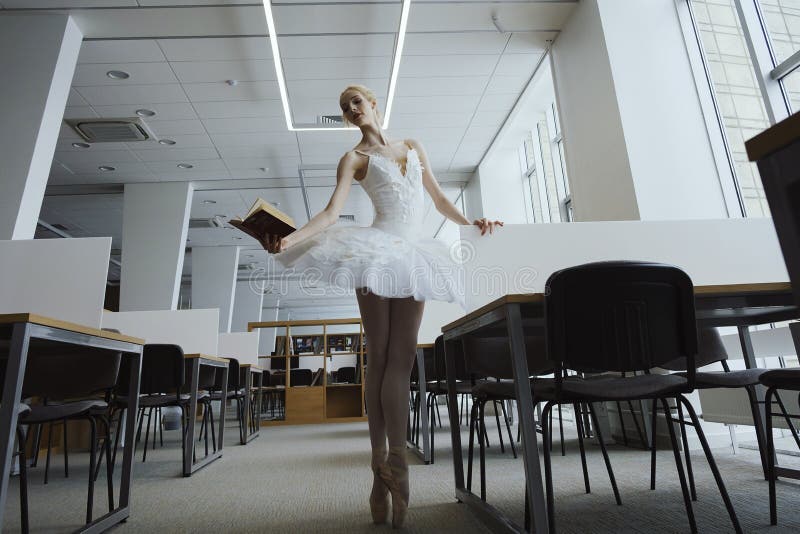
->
[761,369,800,525]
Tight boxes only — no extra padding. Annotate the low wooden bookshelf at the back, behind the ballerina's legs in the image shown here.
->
[247,318,366,426]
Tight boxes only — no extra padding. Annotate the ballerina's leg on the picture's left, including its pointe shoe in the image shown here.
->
[356,289,390,523]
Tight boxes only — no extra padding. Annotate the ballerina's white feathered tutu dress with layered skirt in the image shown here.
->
[275,149,464,307]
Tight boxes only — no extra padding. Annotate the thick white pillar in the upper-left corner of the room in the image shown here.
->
[0,14,83,239]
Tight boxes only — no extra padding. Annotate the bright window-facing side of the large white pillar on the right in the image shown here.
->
[599,0,727,220]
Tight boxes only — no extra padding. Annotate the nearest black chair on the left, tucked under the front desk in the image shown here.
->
[14,348,122,532]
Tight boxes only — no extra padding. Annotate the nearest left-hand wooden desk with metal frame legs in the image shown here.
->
[0,313,144,533]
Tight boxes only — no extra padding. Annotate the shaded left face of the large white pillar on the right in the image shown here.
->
[552,0,636,221]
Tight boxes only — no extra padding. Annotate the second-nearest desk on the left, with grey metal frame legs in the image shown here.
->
[182,354,228,477]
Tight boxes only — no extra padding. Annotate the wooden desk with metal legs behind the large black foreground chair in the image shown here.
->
[442,283,800,532]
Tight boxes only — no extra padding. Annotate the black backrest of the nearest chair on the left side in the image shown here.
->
[20,346,122,400]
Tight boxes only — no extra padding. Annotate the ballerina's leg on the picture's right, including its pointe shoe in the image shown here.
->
[381,298,425,528]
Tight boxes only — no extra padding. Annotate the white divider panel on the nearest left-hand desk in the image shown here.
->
[0,237,111,328]
